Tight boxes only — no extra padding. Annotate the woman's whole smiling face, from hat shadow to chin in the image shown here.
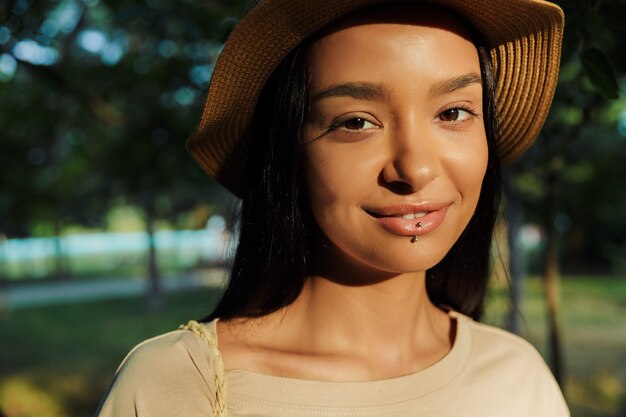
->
[303,7,488,273]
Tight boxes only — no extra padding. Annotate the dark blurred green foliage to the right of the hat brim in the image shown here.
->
[506,0,626,274]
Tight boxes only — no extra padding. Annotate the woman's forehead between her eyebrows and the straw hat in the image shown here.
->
[310,4,480,91]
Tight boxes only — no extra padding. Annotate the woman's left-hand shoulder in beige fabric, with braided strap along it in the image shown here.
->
[97,323,221,417]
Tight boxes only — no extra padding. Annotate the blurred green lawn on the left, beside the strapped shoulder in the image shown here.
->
[0,291,217,417]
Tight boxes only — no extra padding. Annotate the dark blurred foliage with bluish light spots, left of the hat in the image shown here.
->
[0,0,244,237]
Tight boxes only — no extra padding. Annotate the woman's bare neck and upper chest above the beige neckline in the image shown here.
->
[219,266,453,381]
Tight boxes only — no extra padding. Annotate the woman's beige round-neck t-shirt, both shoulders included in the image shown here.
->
[96,312,569,417]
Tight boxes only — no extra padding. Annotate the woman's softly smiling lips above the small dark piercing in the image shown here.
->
[365,203,450,236]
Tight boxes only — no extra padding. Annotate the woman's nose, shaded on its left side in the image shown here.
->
[381,122,441,194]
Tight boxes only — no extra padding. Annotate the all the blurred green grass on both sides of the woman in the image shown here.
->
[0,277,626,417]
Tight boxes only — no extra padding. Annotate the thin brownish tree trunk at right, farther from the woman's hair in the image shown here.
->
[544,156,564,386]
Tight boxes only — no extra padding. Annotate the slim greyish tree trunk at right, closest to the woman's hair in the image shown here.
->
[504,175,526,334]
